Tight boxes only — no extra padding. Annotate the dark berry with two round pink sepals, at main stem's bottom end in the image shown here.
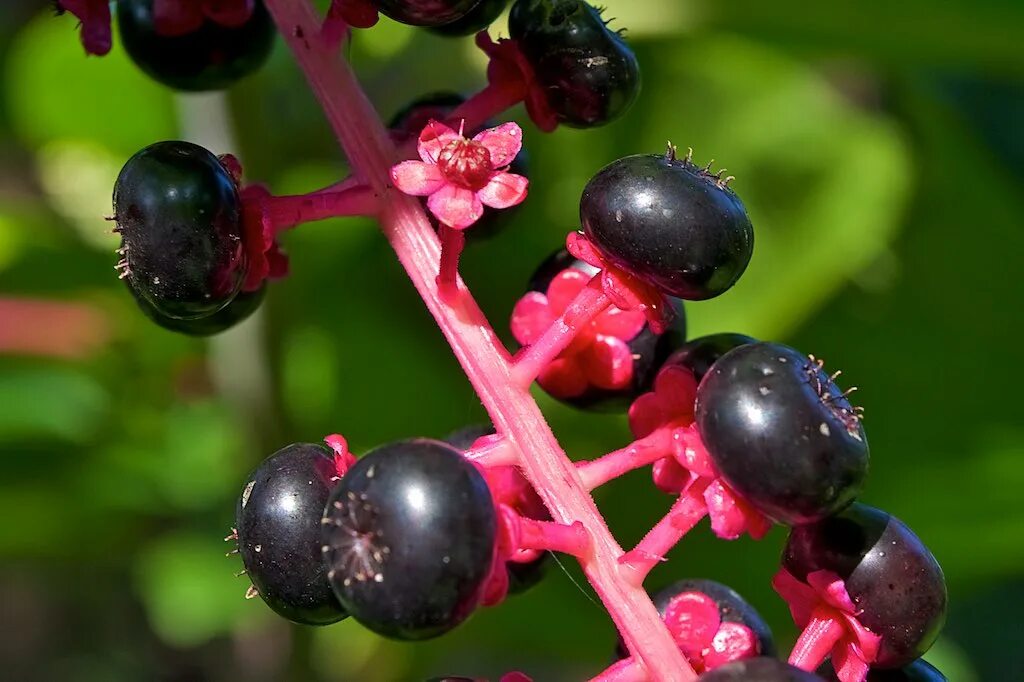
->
[616,580,775,672]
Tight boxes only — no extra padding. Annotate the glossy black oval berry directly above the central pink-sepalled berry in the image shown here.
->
[580,153,754,300]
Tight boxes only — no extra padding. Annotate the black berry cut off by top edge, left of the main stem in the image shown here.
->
[117,0,275,90]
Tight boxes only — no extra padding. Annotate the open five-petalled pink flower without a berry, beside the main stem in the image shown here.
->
[391,121,529,229]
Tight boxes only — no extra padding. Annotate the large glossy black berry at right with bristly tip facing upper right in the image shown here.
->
[696,343,868,524]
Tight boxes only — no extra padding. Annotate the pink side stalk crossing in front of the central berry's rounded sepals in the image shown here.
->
[512,272,611,386]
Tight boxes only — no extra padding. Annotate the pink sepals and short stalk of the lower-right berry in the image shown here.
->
[772,568,882,682]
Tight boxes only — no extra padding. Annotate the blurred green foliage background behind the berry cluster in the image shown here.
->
[0,0,1024,682]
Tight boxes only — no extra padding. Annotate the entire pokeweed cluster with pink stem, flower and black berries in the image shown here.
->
[59,0,946,682]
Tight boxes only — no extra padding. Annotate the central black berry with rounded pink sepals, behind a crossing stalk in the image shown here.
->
[511,249,686,411]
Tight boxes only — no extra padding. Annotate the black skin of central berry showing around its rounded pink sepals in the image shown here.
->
[520,249,686,412]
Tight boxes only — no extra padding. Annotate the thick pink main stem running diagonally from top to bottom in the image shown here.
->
[266,0,696,682]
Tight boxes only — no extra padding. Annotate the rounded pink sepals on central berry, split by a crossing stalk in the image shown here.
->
[510,267,645,398]
